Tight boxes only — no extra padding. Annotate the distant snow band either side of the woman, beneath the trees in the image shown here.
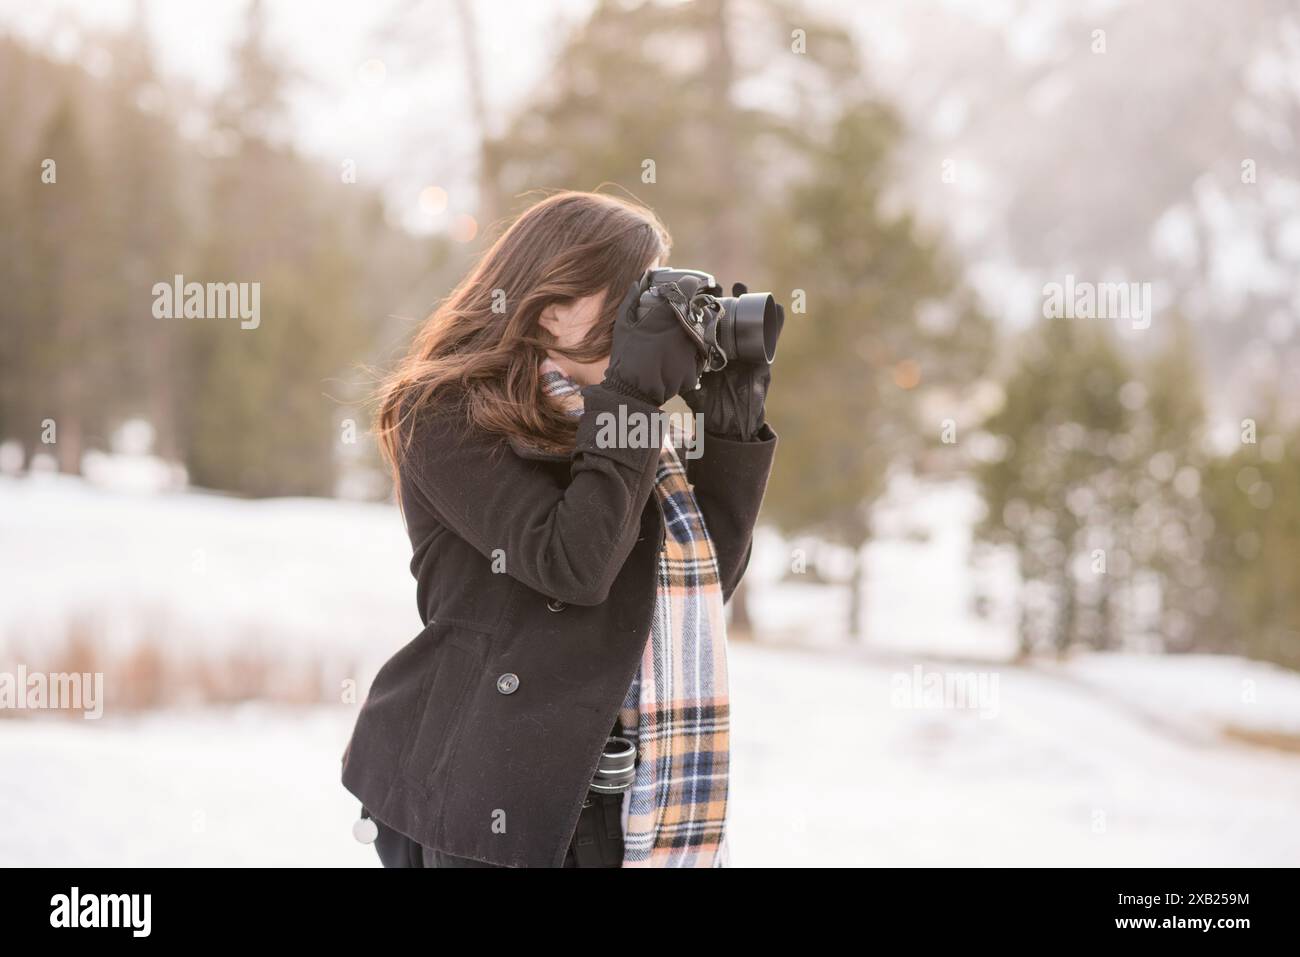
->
[0,465,1015,664]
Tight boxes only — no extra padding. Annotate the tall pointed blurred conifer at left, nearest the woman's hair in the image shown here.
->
[182,3,369,495]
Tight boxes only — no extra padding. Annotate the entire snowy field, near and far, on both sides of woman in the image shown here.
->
[0,477,1300,866]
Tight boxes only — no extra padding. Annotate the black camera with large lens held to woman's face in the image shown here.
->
[641,267,785,372]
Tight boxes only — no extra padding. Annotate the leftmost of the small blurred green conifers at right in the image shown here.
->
[976,319,1141,653]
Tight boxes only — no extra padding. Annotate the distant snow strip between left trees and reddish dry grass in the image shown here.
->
[0,476,420,661]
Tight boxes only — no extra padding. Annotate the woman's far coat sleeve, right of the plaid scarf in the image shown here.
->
[686,425,776,601]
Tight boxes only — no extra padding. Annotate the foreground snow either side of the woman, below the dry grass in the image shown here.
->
[0,645,1300,866]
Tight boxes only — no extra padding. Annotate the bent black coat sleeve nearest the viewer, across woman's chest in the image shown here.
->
[402,385,659,605]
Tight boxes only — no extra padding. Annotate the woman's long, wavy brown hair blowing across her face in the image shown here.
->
[374,191,672,478]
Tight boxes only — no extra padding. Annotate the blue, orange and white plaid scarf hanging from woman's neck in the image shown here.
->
[541,358,731,867]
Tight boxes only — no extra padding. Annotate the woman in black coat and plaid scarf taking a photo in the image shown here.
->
[342,192,776,867]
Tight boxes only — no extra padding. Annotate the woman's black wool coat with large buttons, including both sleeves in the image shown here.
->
[342,385,776,867]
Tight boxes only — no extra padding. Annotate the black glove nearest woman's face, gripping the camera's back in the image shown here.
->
[602,282,705,406]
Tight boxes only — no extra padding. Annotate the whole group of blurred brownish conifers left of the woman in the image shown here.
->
[0,18,434,494]
